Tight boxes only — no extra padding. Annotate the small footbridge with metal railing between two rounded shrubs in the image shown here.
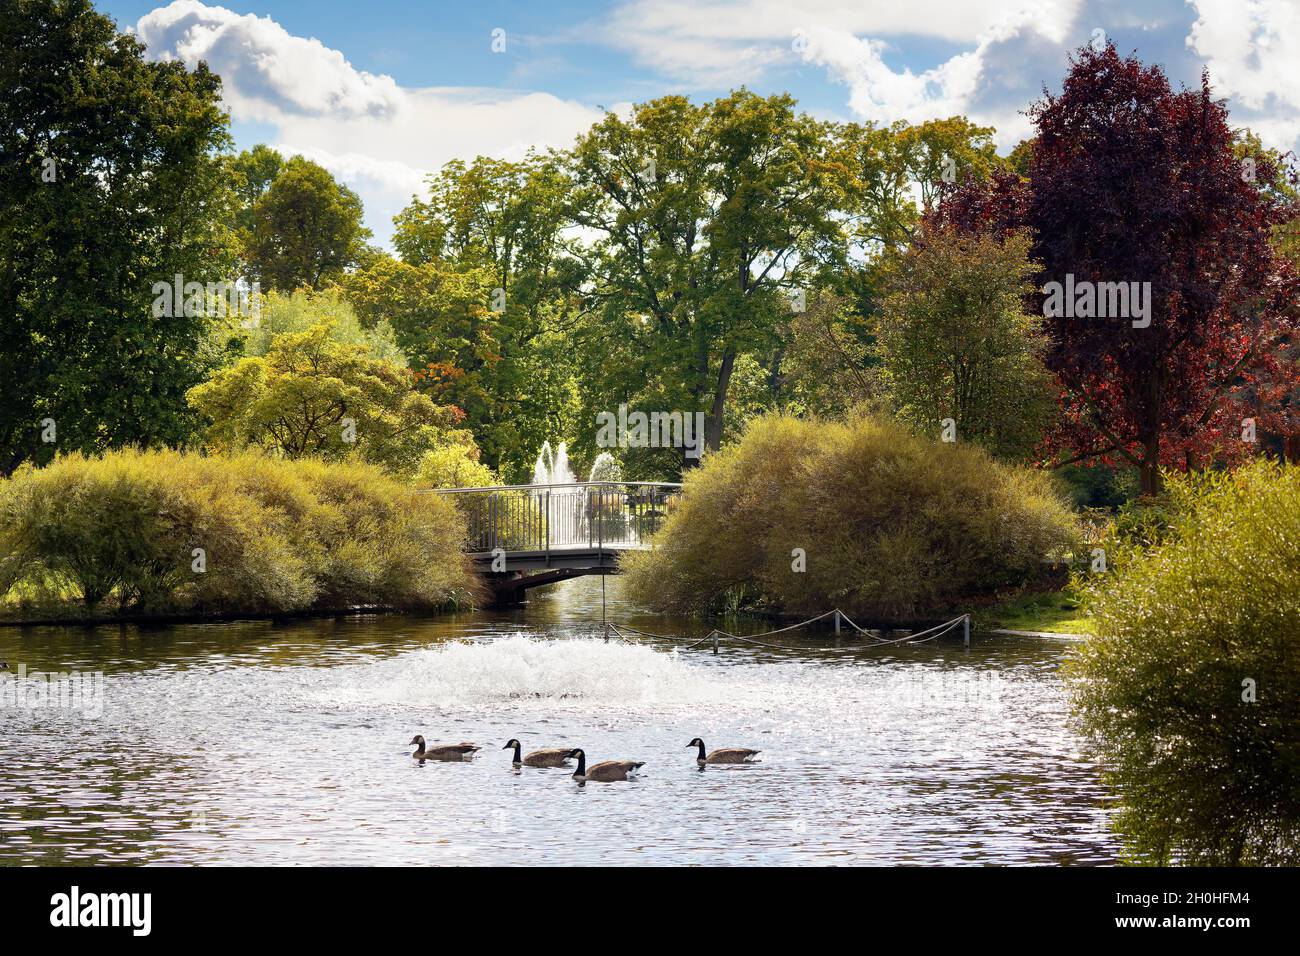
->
[437,481,681,605]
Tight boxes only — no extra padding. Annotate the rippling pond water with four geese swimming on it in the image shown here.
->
[0,579,1117,865]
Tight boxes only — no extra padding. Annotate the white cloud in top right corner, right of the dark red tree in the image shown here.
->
[1187,0,1300,148]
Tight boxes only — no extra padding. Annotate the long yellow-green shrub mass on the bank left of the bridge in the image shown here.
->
[0,450,473,613]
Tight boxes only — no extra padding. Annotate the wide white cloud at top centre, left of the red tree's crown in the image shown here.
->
[602,0,1084,147]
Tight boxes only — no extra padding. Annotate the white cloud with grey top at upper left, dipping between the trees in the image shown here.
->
[137,0,601,241]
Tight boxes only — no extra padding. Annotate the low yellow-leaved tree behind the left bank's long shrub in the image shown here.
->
[189,323,455,475]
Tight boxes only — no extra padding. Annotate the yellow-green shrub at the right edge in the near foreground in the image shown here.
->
[1070,462,1300,865]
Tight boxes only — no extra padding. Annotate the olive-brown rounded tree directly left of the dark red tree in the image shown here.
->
[876,229,1054,458]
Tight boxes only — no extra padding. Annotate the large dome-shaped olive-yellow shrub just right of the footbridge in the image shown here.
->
[625,415,1076,619]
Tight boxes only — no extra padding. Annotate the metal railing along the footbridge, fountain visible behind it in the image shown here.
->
[437,481,681,554]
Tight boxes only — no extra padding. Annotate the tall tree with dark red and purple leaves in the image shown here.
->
[935,46,1300,493]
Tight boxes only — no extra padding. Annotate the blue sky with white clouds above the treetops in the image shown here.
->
[96,0,1300,243]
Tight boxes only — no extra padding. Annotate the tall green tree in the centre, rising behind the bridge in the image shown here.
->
[571,90,844,463]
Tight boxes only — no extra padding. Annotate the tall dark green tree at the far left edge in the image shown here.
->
[0,0,235,472]
